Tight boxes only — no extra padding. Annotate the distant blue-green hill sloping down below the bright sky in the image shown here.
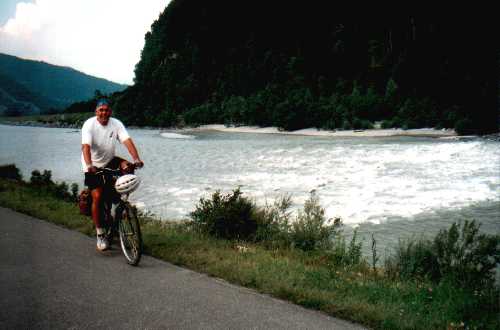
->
[0,54,127,114]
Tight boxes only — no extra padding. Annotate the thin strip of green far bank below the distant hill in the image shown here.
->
[0,112,94,127]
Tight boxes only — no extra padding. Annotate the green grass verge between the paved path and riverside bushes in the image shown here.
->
[0,179,500,329]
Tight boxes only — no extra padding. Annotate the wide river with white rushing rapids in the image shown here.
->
[0,125,500,253]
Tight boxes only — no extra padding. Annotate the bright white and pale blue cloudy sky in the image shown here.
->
[0,0,170,85]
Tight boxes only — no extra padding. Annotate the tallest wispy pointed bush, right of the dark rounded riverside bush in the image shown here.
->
[290,194,341,251]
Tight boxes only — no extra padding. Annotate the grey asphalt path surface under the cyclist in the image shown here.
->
[0,208,368,329]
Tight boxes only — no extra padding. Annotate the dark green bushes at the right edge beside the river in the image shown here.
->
[385,221,500,289]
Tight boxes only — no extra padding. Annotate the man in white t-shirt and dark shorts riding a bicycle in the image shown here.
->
[81,100,144,251]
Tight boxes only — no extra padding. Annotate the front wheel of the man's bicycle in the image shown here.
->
[118,203,142,266]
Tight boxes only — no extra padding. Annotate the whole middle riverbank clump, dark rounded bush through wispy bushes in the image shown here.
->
[191,189,350,253]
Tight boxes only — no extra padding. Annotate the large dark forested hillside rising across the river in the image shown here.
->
[114,0,498,132]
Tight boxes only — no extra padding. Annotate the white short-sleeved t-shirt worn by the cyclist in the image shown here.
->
[81,117,130,172]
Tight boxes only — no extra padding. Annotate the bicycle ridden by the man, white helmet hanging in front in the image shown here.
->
[96,164,143,266]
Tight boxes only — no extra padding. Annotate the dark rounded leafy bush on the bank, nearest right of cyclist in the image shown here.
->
[190,188,257,240]
